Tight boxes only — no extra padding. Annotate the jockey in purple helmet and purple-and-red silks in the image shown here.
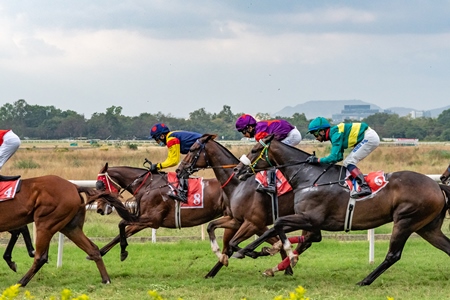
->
[236,114,302,194]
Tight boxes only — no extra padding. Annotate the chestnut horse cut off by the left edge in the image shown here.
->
[0,175,110,286]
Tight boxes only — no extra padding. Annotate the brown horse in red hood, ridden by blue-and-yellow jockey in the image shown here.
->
[97,163,228,261]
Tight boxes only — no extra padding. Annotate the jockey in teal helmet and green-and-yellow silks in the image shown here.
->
[307,117,380,198]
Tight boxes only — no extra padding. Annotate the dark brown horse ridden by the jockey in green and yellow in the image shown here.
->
[234,136,450,286]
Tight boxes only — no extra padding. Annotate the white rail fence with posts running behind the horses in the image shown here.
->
[40,174,441,268]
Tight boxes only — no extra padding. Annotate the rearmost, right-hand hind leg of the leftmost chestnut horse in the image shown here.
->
[61,225,111,283]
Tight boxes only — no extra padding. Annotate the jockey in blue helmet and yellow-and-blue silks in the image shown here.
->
[150,123,202,203]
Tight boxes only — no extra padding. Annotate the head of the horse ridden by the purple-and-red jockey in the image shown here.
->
[177,134,217,177]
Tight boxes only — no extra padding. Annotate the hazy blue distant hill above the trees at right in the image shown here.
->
[272,100,450,119]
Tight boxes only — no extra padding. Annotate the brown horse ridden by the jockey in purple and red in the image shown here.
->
[178,134,304,277]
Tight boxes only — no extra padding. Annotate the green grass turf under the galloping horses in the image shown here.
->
[0,231,450,300]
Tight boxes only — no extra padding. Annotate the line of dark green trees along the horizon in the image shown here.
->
[0,99,450,141]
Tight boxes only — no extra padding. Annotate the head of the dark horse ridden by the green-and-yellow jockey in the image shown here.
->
[234,134,276,180]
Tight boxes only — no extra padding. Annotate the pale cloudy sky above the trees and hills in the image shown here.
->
[0,0,450,118]
